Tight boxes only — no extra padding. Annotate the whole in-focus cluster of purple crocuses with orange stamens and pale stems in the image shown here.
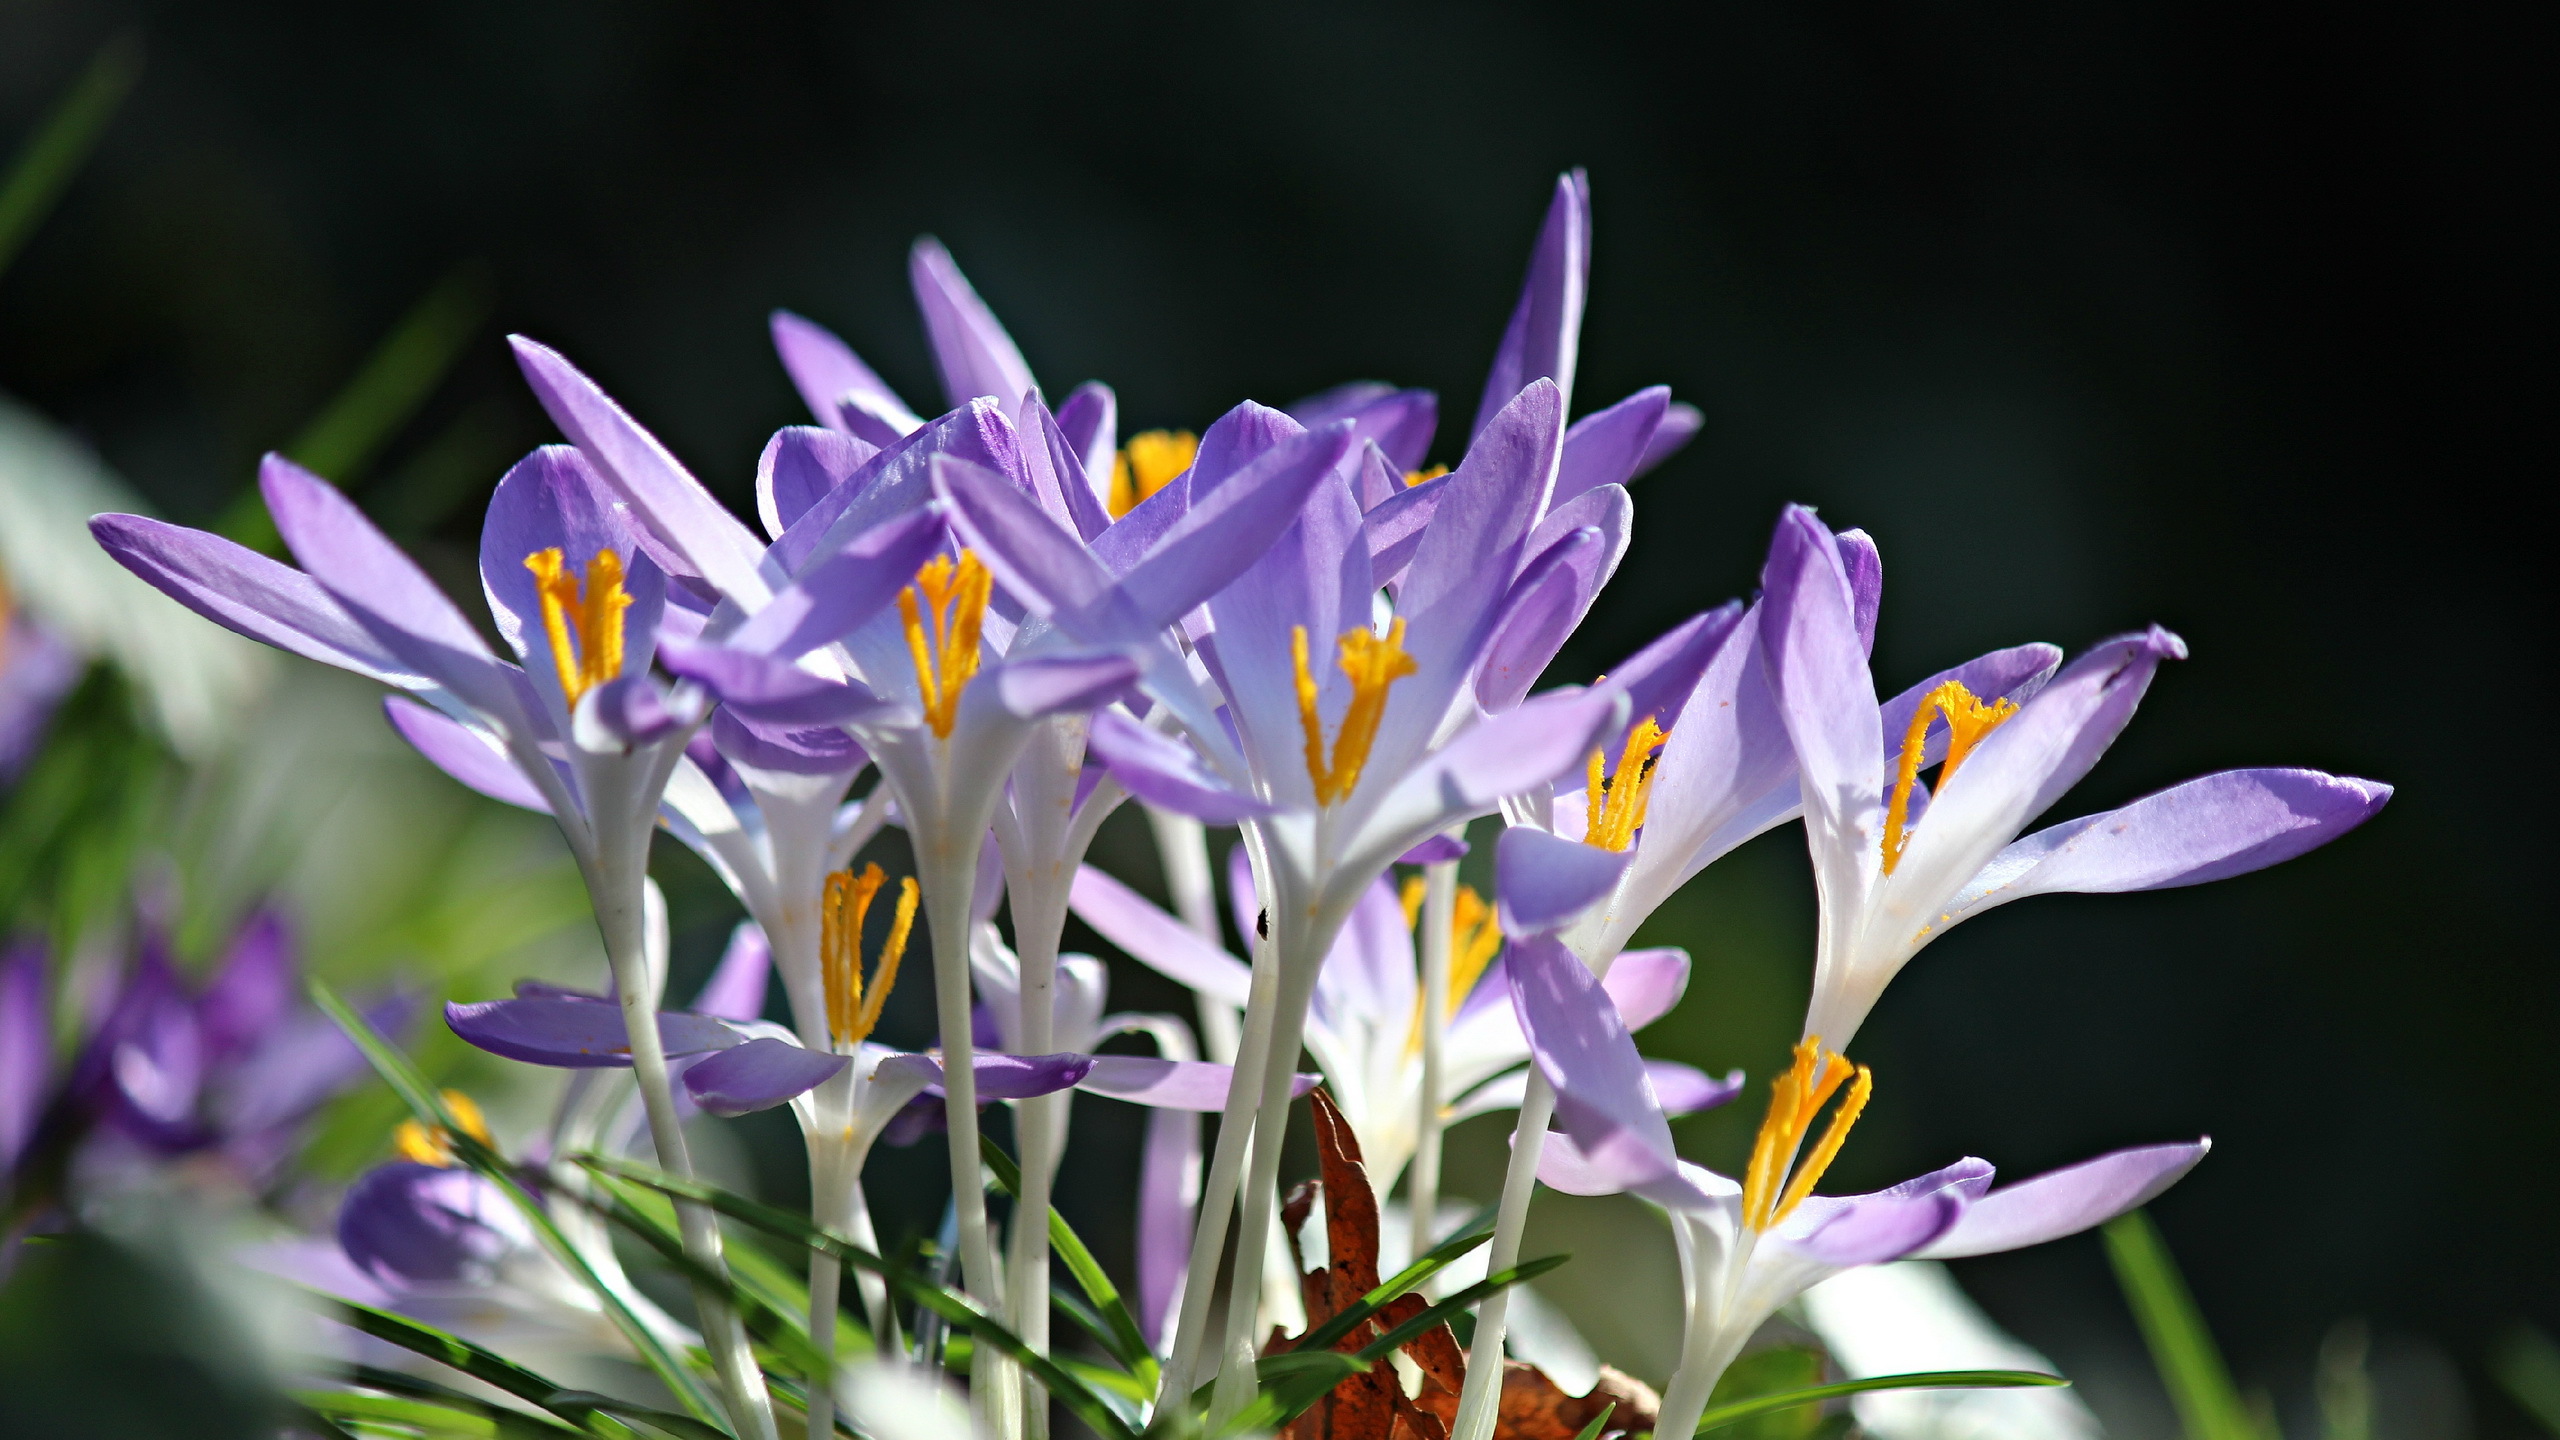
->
[92,174,2388,1440]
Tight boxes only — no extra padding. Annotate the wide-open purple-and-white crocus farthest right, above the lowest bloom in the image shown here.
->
[1761,507,2391,1048]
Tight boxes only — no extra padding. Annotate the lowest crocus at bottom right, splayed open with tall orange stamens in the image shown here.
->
[1510,917,2209,1435]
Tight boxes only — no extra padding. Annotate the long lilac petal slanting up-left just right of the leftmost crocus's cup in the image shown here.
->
[507,336,771,605]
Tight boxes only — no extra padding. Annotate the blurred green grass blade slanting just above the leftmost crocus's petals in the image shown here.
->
[215,261,492,553]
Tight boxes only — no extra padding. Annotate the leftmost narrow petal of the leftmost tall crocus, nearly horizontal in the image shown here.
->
[90,515,414,689]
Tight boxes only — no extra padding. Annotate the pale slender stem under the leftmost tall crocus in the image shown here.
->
[586,799,776,1440]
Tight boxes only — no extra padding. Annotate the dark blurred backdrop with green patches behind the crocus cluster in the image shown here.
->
[0,0,2560,1437]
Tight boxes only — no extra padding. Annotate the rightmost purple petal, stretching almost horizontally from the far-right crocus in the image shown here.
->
[1948,769,2391,917]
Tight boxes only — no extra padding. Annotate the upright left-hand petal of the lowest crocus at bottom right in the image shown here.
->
[1505,938,1679,1189]
